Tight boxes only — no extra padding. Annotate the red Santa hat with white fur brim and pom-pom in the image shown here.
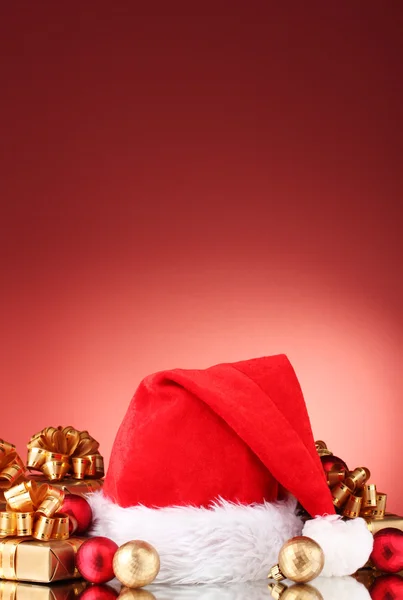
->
[90,355,373,584]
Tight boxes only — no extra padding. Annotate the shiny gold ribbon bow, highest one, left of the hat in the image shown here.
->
[27,427,104,481]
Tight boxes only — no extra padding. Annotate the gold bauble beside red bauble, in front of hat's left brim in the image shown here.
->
[113,540,160,588]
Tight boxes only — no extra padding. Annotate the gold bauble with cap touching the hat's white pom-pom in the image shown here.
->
[268,536,325,583]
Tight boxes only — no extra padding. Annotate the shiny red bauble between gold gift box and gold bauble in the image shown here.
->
[76,537,118,583]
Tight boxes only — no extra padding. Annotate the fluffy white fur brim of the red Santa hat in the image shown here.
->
[88,492,302,584]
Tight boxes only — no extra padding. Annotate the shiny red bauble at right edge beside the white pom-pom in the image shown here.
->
[371,527,403,573]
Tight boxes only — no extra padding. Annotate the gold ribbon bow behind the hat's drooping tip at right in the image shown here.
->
[315,441,387,519]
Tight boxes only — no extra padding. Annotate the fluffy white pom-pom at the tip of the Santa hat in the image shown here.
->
[302,515,374,577]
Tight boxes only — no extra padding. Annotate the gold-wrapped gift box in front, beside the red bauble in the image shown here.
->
[0,537,86,583]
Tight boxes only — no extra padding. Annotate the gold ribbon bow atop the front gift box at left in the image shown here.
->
[0,481,69,542]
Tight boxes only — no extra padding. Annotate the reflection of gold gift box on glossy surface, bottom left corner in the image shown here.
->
[0,581,88,600]
